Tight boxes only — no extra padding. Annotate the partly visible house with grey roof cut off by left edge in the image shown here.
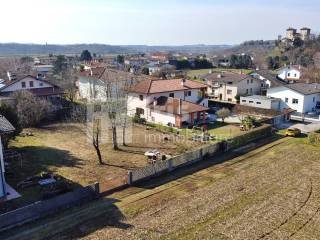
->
[0,115,15,201]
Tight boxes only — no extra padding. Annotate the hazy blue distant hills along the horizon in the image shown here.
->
[0,43,232,56]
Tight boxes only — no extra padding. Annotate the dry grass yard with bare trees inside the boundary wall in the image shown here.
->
[0,124,199,211]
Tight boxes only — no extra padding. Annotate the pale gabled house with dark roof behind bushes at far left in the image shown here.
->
[0,75,64,98]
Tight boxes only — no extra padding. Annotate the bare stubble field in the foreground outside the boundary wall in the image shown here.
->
[3,138,320,240]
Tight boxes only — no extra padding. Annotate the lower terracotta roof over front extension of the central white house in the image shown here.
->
[149,96,209,115]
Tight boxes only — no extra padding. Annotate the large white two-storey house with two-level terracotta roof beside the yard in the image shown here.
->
[128,79,208,127]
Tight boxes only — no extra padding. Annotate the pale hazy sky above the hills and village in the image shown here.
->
[0,0,320,45]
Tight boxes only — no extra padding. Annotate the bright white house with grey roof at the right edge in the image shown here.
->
[267,83,320,114]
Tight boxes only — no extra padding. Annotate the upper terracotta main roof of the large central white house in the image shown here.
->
[130,79,207,94]
